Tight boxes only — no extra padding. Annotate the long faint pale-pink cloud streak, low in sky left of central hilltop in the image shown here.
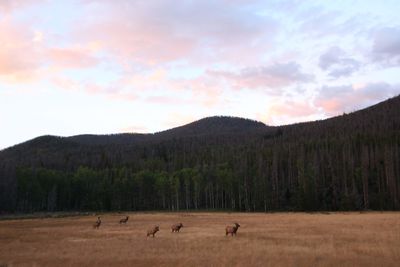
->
[51,68,222,107]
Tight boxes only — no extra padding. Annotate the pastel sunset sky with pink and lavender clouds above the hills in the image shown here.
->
[0,0,400,149]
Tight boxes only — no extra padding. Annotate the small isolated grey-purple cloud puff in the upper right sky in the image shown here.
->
[319,46,361,78]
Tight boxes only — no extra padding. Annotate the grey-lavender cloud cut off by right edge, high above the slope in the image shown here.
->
[372,28,400,66]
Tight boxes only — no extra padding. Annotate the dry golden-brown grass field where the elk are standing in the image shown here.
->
[0,212,400,266]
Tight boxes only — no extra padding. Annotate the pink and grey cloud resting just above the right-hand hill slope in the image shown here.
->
[314,83,400,116]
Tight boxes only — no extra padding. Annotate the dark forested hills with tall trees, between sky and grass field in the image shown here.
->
[0,96,400,212]
